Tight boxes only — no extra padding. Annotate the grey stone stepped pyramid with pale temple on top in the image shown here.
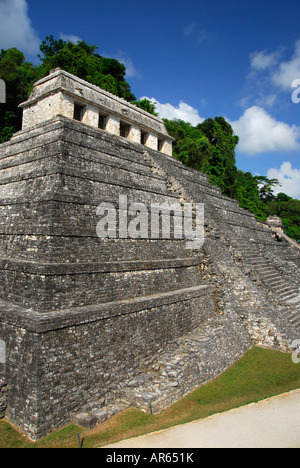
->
[0,69,300,440]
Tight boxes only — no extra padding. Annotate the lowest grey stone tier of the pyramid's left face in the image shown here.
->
[0,286,215,439]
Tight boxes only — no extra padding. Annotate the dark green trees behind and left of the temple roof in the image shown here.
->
[0,36,136,143]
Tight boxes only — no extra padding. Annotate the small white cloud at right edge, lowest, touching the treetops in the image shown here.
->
[267,161,300,200]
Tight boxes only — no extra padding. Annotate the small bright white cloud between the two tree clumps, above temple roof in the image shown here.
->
[141,96,204,126]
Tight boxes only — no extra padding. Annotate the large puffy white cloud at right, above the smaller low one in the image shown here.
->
[231,106,300,155]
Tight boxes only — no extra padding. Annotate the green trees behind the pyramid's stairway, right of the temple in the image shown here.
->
[164,117,300,240]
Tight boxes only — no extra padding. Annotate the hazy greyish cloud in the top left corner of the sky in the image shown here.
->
[0,0,41,55]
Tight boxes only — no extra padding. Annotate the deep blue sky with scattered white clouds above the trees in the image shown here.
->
[0,0,300,199]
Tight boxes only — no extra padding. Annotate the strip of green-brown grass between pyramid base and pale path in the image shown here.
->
[0,348,300,448]
